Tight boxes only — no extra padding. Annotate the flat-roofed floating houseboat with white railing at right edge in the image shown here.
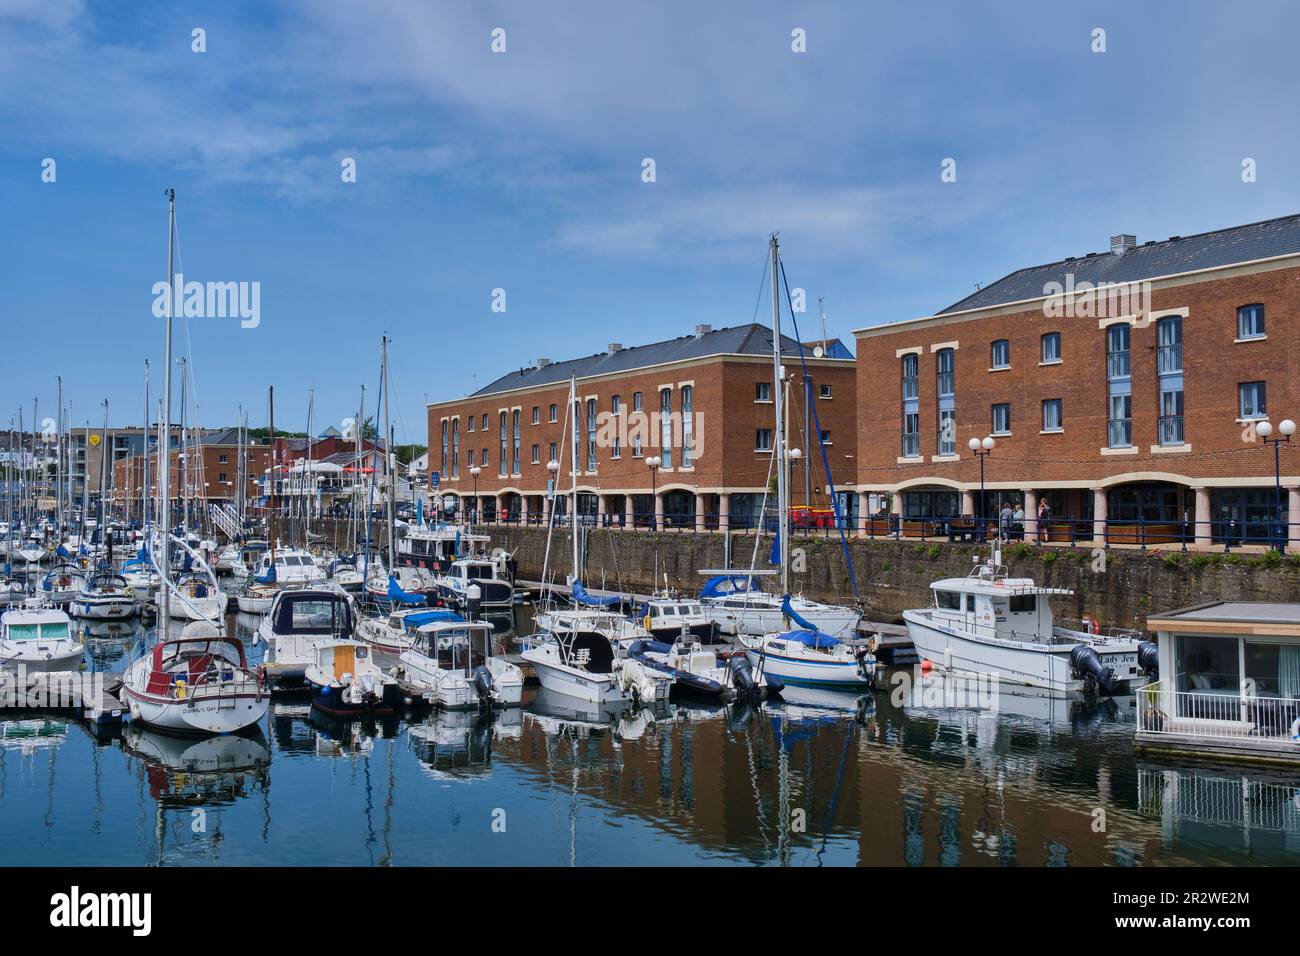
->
[1136,601,1300,763]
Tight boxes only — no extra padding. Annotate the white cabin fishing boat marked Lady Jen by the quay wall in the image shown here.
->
[902,541,1144,696]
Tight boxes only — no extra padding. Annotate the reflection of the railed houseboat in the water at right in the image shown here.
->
[1138,761,1300,864]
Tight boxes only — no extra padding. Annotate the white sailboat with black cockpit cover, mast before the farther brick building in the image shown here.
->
[521,377,673,704]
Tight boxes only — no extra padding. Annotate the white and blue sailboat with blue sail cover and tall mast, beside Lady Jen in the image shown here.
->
[737,234,875,688]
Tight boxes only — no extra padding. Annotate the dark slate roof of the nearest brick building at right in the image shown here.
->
[936,213,1300,315]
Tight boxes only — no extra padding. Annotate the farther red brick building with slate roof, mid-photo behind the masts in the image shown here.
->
[428,325,857,529]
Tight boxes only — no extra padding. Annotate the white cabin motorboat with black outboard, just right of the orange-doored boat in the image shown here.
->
[398,620,524,709]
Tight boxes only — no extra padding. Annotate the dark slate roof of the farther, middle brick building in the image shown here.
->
[473,324,852,397]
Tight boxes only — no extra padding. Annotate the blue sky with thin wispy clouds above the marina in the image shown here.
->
[0,0,1300,441]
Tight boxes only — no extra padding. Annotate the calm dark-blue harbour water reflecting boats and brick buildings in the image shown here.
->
[0,607,1300,866]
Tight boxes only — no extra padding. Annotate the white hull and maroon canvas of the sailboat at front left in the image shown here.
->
[122,620,270,734]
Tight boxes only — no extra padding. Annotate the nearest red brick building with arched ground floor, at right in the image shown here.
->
[854,216,1300,544]
